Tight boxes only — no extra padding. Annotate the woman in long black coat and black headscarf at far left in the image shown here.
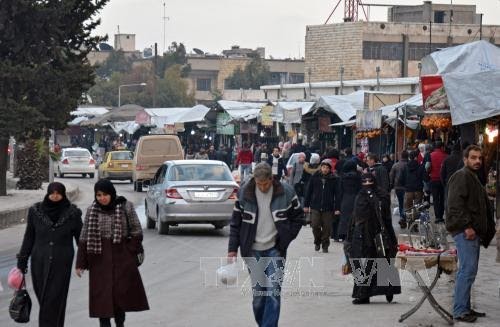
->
[17,182,82,327]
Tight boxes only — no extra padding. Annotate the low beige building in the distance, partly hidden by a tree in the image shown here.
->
[187,46,304,103]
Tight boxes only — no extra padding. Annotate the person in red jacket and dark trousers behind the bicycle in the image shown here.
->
[429,140,448,223]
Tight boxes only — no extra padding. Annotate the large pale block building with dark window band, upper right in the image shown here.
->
[305,1,500,82]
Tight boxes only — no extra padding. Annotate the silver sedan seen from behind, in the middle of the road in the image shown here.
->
[145,160,238,234]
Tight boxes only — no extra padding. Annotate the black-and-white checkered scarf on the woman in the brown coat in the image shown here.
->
[84,201,125,254]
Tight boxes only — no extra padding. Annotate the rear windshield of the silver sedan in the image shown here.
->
[169,164,233,182]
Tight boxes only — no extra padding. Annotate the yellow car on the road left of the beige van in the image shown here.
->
[97,150,134,182]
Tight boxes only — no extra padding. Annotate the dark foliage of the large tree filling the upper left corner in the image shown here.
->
[0,0,109,195]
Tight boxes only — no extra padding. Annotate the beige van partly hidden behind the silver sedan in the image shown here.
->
[132,135,184,192]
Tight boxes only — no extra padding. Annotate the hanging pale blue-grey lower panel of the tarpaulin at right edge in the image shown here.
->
[443,70,500,125]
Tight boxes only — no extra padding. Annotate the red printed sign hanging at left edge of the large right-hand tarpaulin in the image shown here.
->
[420,75,450,112]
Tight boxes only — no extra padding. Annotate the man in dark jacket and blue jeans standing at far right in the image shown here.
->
[446,145,495,322]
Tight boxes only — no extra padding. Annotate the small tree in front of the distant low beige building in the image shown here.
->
[227,53,270,89]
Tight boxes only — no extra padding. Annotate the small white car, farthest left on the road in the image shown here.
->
[54,148,95,178]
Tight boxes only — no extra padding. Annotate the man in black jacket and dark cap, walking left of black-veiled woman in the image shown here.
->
[304,160,340,253]
